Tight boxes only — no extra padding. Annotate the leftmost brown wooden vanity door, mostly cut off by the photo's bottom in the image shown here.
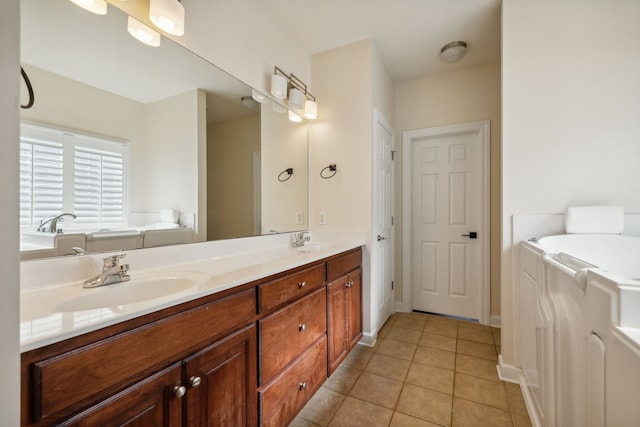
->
[58,364,182,427]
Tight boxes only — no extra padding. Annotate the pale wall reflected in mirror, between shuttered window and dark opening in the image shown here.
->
[143,90,206,241]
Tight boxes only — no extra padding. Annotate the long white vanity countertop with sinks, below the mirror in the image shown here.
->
[20,235,364,352]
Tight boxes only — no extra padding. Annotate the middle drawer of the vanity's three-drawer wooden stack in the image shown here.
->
[260,287,327,384]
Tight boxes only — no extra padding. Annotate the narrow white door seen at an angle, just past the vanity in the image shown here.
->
[372,110,395,330]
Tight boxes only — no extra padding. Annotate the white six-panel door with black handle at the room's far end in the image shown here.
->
[405,122,489,323]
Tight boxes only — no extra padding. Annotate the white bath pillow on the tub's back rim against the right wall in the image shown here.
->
[564,206,624,234]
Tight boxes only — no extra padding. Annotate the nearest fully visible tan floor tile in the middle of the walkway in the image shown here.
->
[396,384,452,426]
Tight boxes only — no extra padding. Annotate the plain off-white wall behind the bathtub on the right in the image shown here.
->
[501,0,640,365]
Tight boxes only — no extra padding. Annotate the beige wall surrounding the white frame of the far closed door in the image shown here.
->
[395,64,501,316]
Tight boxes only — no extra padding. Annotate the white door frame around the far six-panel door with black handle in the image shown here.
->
[402,120,491,325]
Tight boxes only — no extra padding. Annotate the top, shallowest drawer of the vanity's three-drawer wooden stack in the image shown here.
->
[258,264,326,313]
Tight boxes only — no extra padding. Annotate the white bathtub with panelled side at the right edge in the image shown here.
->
[519,234,640,426]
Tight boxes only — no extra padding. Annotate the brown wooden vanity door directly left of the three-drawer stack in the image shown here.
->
[184,325,258,427]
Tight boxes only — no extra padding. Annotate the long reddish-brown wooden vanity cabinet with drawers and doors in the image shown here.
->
[21,245,362,426]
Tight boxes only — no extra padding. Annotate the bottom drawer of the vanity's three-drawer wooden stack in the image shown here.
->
[259,335,327,426]
